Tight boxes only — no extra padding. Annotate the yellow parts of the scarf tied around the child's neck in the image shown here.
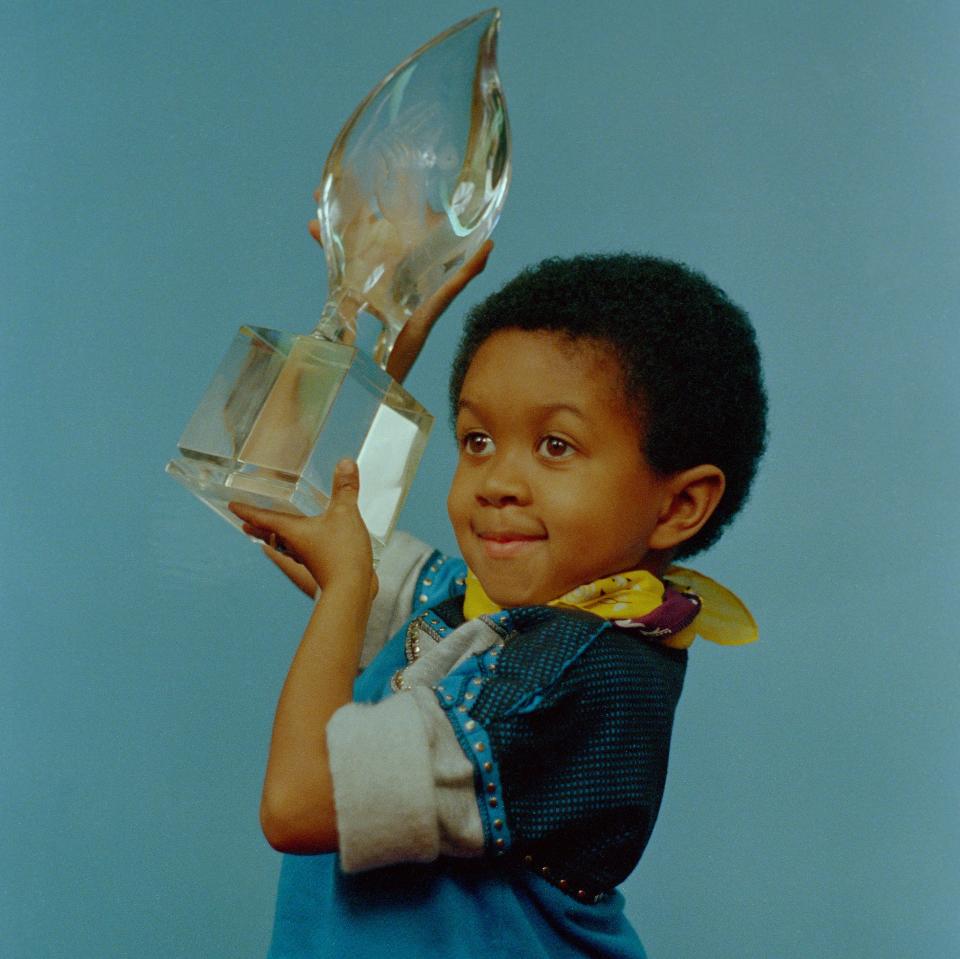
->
[463,566,757,649]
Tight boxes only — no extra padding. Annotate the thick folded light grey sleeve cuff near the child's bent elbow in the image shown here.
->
[327,694,440,873]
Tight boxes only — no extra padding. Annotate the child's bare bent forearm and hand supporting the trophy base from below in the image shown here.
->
[230,461,377,853]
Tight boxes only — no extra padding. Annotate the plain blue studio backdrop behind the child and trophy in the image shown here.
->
[0,0,960,959]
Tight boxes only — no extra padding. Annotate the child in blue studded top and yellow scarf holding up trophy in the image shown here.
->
[234,255,766,959]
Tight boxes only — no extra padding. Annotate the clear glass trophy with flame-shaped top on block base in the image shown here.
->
[167,9,510,556]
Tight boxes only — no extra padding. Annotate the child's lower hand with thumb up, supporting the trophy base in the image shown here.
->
[230,460,377,600]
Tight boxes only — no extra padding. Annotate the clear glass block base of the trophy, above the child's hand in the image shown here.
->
[167,326,433,557]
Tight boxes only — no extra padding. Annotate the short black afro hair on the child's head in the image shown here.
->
[450,253,767,559]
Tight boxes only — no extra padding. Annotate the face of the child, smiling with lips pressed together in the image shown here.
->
[447,330,666,607]
